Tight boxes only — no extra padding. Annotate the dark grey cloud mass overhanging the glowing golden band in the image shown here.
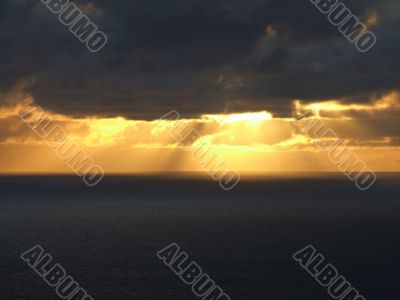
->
[0,0,400,119]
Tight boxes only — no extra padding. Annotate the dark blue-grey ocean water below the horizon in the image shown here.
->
[0,174,400,300]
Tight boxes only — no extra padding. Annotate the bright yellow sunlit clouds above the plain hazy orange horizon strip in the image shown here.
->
[0,84,400,151]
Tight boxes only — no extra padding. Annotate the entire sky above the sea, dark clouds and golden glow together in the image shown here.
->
[0,0,400,173]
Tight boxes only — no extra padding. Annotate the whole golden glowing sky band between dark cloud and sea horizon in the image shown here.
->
[0,88,400,173]
